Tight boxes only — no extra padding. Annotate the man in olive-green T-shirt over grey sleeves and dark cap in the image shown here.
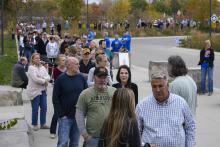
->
[76,67,116,147]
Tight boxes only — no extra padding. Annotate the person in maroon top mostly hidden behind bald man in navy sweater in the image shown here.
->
[50,54,66,139]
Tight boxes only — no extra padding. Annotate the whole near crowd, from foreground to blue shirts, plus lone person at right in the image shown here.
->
[12,20,217,147]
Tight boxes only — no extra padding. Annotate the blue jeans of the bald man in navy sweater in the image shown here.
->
[57,117,80,147]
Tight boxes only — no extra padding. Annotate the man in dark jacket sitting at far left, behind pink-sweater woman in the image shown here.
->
[11,57,28,89]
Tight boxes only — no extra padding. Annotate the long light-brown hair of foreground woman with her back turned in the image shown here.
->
[102,88,136,147]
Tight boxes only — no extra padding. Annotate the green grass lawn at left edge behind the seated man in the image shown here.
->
[0,35,18,85]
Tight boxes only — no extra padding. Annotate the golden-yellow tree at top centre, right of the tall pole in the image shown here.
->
[108,0,131,22]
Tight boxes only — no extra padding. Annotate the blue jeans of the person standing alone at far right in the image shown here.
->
[201,67,213,93]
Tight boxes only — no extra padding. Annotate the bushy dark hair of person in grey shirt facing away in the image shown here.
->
[168,56,188,77]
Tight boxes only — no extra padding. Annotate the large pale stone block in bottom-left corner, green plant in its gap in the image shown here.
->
[0,106,34,147]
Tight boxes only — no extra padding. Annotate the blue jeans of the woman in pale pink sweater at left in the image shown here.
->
[31,91,47,126]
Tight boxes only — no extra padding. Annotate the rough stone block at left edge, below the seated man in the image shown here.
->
[0,85,23,106]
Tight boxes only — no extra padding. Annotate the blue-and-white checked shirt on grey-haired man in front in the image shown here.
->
[136,94,195,147]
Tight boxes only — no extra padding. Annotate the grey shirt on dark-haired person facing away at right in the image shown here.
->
[170,75,197,115]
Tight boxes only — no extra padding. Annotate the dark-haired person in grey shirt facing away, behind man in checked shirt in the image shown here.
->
[167,56,197,116]
